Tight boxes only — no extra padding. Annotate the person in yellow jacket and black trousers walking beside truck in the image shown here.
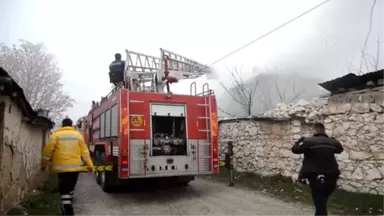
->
[41,118,93,216]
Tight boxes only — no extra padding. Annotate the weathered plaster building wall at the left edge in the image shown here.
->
[0,97,48,215]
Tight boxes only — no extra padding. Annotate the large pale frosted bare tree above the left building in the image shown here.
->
[0,40,74,121]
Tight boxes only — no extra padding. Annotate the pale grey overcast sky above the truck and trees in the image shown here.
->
[0,0,384,119]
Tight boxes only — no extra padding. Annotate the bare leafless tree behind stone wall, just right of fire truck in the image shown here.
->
[220,67,258,116]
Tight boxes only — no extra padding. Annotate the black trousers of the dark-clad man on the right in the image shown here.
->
[308,175,339,216]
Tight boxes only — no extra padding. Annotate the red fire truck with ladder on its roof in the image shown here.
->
[80,49,219,192]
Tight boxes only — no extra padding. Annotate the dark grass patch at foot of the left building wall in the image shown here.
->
[7,175,61,216]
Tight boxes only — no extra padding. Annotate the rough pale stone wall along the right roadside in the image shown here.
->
[220,89,384,194]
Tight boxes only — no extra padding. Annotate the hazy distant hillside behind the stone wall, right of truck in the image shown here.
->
[218,73,326,117]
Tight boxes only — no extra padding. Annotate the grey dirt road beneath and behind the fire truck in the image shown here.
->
[74,174,313,216]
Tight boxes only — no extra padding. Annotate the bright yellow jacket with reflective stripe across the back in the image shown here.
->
[41,127,93,172]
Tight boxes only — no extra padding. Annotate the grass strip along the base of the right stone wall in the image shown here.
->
[211,168,384,216]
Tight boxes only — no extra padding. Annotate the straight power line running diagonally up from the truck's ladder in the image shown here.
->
[208,0,331,67]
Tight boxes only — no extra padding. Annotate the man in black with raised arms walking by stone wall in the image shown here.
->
[292,123,343,216]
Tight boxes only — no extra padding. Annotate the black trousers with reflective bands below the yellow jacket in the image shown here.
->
[58,172,79,216]
